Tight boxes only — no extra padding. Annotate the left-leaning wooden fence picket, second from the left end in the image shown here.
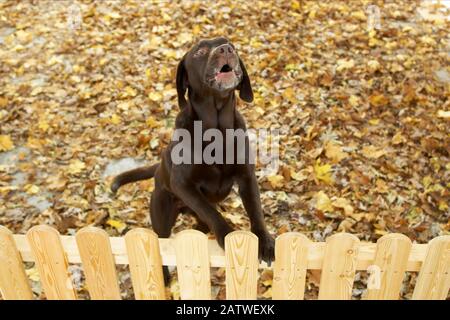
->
[27,225,77,300]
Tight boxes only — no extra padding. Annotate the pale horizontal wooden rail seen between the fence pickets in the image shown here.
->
[14,235,427,271]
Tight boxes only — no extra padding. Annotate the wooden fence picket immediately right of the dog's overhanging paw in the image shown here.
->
[273,232,310,300]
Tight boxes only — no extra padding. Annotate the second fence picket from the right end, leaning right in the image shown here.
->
[368,233,412,300]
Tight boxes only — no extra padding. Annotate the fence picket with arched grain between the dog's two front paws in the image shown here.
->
[225,231,258,300]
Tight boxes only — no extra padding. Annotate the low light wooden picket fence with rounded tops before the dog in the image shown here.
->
[0,225,450,300]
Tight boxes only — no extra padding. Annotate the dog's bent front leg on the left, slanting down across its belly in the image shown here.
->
[171,179,233,248]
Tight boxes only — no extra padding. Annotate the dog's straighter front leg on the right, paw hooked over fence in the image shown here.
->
[238,170,275,264]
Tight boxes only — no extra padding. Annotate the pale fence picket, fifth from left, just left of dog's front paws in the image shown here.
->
[175,230,211,300]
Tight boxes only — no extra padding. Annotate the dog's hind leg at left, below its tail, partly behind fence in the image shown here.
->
[150,183,179,285]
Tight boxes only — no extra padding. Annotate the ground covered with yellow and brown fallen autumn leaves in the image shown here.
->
[0,0,450,299]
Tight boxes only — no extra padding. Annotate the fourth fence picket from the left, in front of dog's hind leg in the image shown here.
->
[125,228,166,300]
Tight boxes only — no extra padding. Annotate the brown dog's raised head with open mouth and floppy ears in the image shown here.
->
[177,38,253,108]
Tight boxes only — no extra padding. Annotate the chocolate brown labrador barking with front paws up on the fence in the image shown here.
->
[111,38,274,272]
